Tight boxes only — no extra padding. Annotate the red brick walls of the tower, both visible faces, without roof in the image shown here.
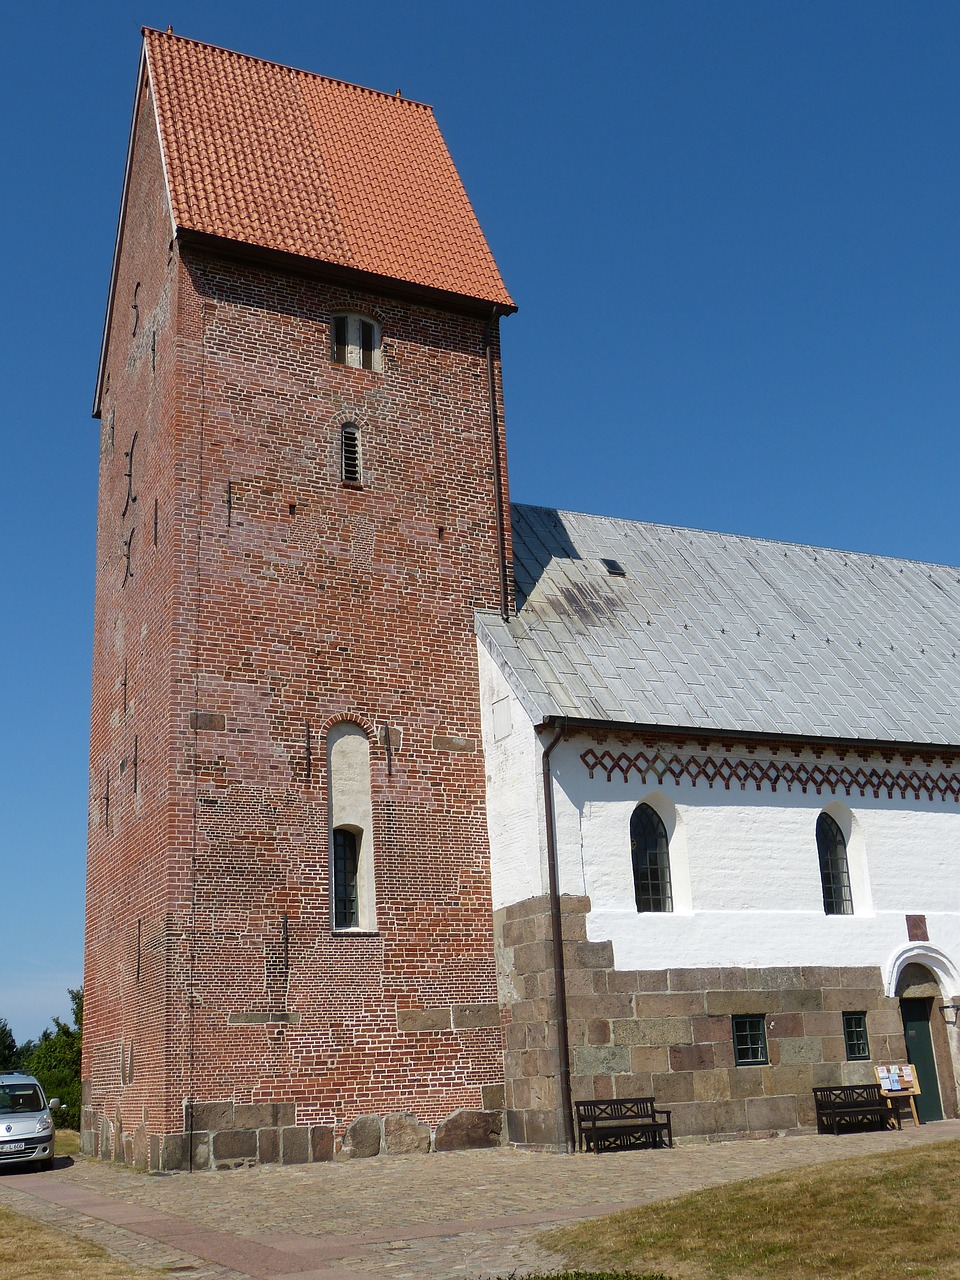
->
[84,85,506,1157]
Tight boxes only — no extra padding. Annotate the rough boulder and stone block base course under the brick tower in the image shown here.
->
[81,1102,503,1171]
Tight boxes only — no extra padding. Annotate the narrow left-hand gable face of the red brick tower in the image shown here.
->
[83,82,184,1152]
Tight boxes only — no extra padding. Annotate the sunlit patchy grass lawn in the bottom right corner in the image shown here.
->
[541,1142,960,1280]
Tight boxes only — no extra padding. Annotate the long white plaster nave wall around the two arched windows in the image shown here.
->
[554,739,960,969]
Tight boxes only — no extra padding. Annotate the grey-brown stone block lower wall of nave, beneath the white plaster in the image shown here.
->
[495,896,926,1146]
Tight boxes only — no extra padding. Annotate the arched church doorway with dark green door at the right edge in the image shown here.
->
[891,948,957,1121]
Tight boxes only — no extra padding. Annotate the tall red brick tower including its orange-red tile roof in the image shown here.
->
[83,31,515,1169]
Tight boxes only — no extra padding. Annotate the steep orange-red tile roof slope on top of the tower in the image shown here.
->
[143,29,512,307]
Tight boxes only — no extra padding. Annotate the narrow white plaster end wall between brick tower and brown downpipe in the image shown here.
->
[477,645,547,910]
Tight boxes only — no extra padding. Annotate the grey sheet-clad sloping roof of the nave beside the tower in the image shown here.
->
[476,506,960,746]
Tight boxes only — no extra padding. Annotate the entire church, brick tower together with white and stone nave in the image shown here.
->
[82,29,960,1170]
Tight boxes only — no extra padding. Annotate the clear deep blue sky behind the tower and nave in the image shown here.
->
[0,0,960,1039]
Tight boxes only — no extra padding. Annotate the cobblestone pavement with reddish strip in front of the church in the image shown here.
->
[0,1120,960,1280]
